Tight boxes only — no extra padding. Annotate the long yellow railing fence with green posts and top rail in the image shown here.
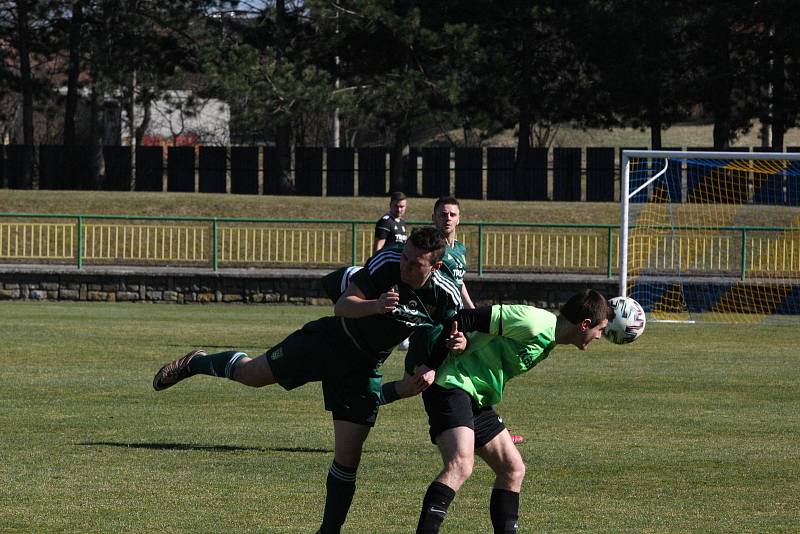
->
[0,213,800,279]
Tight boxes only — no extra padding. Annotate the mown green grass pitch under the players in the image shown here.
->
[0,302,800,533]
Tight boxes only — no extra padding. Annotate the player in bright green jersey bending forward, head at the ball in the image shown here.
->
[409,290,613,534]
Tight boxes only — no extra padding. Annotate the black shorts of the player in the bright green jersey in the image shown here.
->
[422,384,506,449]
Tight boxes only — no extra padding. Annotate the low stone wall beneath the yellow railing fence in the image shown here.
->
[0,266,617,308]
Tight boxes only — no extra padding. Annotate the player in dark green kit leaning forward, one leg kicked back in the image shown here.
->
[153,227,460,533]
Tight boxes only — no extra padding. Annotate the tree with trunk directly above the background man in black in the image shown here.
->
[309,0,468,193]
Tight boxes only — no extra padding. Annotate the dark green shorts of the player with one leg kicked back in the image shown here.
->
[266,317,381,426]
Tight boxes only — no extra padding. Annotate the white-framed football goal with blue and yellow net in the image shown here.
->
[619,151,800,322]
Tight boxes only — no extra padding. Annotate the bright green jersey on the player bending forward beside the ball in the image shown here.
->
[436,304,556,408]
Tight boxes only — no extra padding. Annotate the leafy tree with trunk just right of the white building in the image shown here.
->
[202,0,333,194]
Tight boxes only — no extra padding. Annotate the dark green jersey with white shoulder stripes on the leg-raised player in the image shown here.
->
[323,245,461,364]
